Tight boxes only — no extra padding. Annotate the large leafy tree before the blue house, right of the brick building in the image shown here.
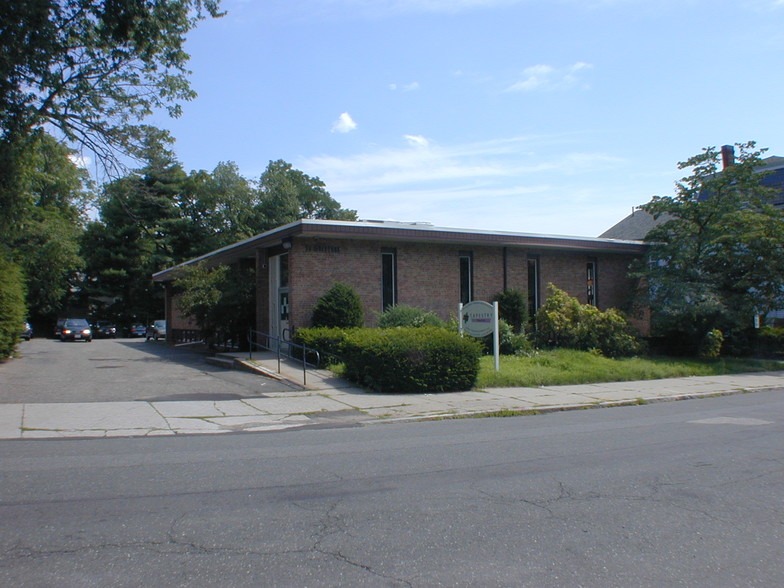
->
[636,142,784,348]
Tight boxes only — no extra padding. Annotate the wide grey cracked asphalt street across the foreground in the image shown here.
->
[0,391,784,588]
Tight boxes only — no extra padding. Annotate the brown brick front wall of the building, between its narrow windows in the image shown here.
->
[282,238,644,329]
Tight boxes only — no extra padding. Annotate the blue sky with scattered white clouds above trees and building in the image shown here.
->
[147,0,784,236]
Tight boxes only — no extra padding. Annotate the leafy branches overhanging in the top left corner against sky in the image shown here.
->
[0,0,221,171]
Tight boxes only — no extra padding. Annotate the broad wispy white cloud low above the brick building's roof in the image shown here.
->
[297,135,626,236]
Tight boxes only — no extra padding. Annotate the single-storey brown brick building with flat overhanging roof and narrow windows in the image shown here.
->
[153,219,648,338]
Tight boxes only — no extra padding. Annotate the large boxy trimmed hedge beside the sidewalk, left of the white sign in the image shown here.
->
[343,327,481,393]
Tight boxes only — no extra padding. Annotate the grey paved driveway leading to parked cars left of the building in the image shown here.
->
[0,339,290,404]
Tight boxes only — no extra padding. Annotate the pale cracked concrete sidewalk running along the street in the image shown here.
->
[0,355,784,439]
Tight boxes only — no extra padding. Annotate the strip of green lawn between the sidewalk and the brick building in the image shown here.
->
[476,349,784,389]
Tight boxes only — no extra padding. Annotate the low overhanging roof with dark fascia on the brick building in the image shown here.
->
[153,219,647,282]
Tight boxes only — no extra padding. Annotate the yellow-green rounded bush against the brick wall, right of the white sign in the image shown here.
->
[534,284,642,357]
